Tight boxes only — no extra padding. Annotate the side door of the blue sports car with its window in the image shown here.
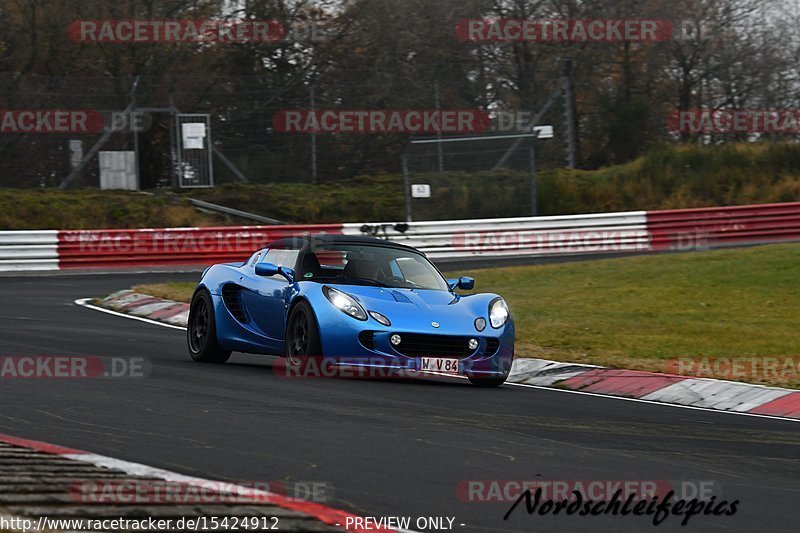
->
[241,249,299,351]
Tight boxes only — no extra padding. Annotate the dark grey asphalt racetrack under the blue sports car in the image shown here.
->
[0,273,800,531]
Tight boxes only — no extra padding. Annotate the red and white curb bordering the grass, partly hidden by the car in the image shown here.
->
[83,290,800,420]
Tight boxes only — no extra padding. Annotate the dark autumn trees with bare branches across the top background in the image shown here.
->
[0,0,800,186]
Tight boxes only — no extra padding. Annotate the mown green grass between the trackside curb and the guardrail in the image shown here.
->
[134,244,800,388]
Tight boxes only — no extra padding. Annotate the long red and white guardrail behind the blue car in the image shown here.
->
[0,202,800,271]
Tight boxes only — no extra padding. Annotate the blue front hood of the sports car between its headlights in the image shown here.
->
[330,285,496,333]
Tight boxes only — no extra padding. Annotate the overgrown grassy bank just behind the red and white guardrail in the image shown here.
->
[0,143,800,229]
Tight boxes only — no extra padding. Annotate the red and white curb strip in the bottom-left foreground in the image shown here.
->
[0,433,405,533]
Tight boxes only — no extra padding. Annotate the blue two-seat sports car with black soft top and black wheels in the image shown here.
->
[187,235,514,387]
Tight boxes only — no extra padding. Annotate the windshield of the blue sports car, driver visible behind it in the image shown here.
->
[299,244,448,291]
